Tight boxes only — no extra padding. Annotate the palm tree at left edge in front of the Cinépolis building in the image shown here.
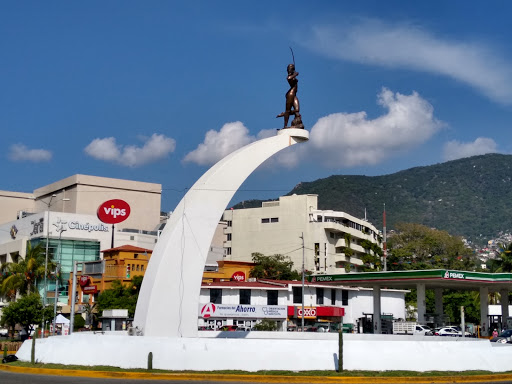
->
[0,242,53,300]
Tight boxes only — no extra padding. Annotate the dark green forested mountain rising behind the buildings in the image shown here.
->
[234,154,512,244]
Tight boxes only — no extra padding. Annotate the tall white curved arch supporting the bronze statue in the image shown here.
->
[134,128,309,337]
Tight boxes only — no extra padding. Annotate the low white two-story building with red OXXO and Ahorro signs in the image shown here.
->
[198,279,407,332]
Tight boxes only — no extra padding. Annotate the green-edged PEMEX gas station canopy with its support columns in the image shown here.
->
[308,269,512,337]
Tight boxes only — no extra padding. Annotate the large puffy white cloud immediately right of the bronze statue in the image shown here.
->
[297,88,444,167]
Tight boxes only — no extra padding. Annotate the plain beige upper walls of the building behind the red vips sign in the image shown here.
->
[0,175,162,231]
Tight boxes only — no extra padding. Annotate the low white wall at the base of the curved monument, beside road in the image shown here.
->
[16,332,512,372]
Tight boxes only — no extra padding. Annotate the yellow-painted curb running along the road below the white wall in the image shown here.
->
[0,364,512,384]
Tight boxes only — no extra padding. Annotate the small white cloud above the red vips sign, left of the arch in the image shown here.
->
[84,133,176,167]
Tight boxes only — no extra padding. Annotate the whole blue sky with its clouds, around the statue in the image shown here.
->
[0,0,512,211]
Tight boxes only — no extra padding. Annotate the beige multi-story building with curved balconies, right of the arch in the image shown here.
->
[223,195,382,274]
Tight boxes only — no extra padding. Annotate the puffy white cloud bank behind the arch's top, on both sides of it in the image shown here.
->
[183,88,444,168]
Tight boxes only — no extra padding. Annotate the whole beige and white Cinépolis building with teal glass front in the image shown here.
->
[0,175,162,310]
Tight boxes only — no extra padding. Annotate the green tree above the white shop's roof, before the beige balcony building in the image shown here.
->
[250,253,301,280]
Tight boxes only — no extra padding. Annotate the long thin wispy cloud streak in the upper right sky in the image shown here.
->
[306,20,512,103]
